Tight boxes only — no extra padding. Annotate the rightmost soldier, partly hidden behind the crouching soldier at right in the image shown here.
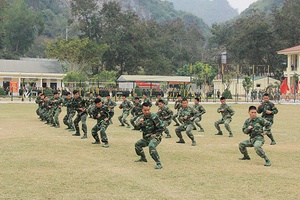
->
[257,94,278,145]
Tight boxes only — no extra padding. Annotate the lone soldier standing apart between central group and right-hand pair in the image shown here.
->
[215,97,234,137]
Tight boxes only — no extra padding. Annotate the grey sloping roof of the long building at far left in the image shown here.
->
[0,59,65,74]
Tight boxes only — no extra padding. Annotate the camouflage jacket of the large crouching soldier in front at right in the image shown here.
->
[242,117,271,139]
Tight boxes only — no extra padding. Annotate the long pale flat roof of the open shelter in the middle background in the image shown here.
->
[117,75,190,83]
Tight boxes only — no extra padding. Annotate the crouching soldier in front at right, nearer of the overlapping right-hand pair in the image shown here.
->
[239,106,271,166]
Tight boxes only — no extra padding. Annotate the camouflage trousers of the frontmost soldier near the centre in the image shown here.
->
[134,136,161,163]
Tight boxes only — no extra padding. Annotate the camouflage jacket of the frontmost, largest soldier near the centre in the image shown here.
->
[135,113,165,140]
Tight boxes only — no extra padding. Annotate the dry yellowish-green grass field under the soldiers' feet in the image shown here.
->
[0,104,300,199]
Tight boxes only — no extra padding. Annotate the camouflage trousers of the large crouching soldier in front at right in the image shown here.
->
[239,137,266,158]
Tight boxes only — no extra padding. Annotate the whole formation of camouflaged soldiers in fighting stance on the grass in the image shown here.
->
[36,90,278,169]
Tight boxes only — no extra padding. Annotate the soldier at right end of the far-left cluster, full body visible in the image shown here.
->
[50,91,63,128]
